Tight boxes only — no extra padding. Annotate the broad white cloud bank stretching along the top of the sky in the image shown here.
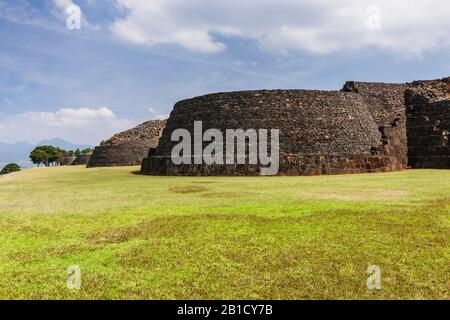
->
[111,0,450,55]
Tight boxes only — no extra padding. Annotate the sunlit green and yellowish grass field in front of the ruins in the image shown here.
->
[0,167,450,299]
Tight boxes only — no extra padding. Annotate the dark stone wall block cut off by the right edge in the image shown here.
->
[405,78,450,169]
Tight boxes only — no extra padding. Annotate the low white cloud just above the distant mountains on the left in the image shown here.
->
[0,107,137,145]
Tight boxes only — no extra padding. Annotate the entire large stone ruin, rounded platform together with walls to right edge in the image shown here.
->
[141,79,450,175]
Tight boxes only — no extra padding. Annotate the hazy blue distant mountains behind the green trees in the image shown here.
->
[0,138,92,170]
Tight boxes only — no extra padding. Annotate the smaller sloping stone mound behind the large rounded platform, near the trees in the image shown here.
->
[88,120,165,168]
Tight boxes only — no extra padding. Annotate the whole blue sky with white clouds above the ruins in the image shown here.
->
[0,0,450,145]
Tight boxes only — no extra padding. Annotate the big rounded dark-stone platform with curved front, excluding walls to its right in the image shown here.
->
[141,90,404,175]
